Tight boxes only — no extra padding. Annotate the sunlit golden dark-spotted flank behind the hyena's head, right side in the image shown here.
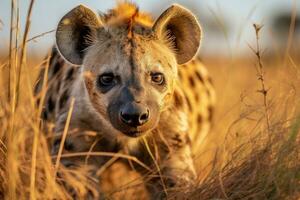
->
[179,59,216,152]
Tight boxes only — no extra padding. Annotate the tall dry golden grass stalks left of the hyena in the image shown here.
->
[0,0,102,199]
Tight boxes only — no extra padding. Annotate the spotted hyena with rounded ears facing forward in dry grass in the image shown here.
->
[36,2,215,199]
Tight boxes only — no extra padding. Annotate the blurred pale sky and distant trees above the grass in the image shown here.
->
[0,0,300,57]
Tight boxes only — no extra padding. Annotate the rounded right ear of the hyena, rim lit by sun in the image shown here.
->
[153,4,201,64]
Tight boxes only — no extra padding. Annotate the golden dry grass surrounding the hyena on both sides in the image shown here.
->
[0,0,300,200]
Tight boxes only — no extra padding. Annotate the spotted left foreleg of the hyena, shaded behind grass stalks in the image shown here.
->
[51,119,115,199]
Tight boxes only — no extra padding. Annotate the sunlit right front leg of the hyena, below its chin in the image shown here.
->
[141,112,197,199]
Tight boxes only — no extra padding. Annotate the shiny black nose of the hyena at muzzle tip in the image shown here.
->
[120,103,149,127]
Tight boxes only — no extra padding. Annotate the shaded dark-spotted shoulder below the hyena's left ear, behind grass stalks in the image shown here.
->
[34,47,80,123]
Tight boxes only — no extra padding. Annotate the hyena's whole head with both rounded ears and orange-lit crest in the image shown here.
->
[56,3,201,137]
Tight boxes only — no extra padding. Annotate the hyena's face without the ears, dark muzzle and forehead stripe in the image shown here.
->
[83,32,177,137]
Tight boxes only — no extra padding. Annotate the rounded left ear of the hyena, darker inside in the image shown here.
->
[56,5,101,65]
